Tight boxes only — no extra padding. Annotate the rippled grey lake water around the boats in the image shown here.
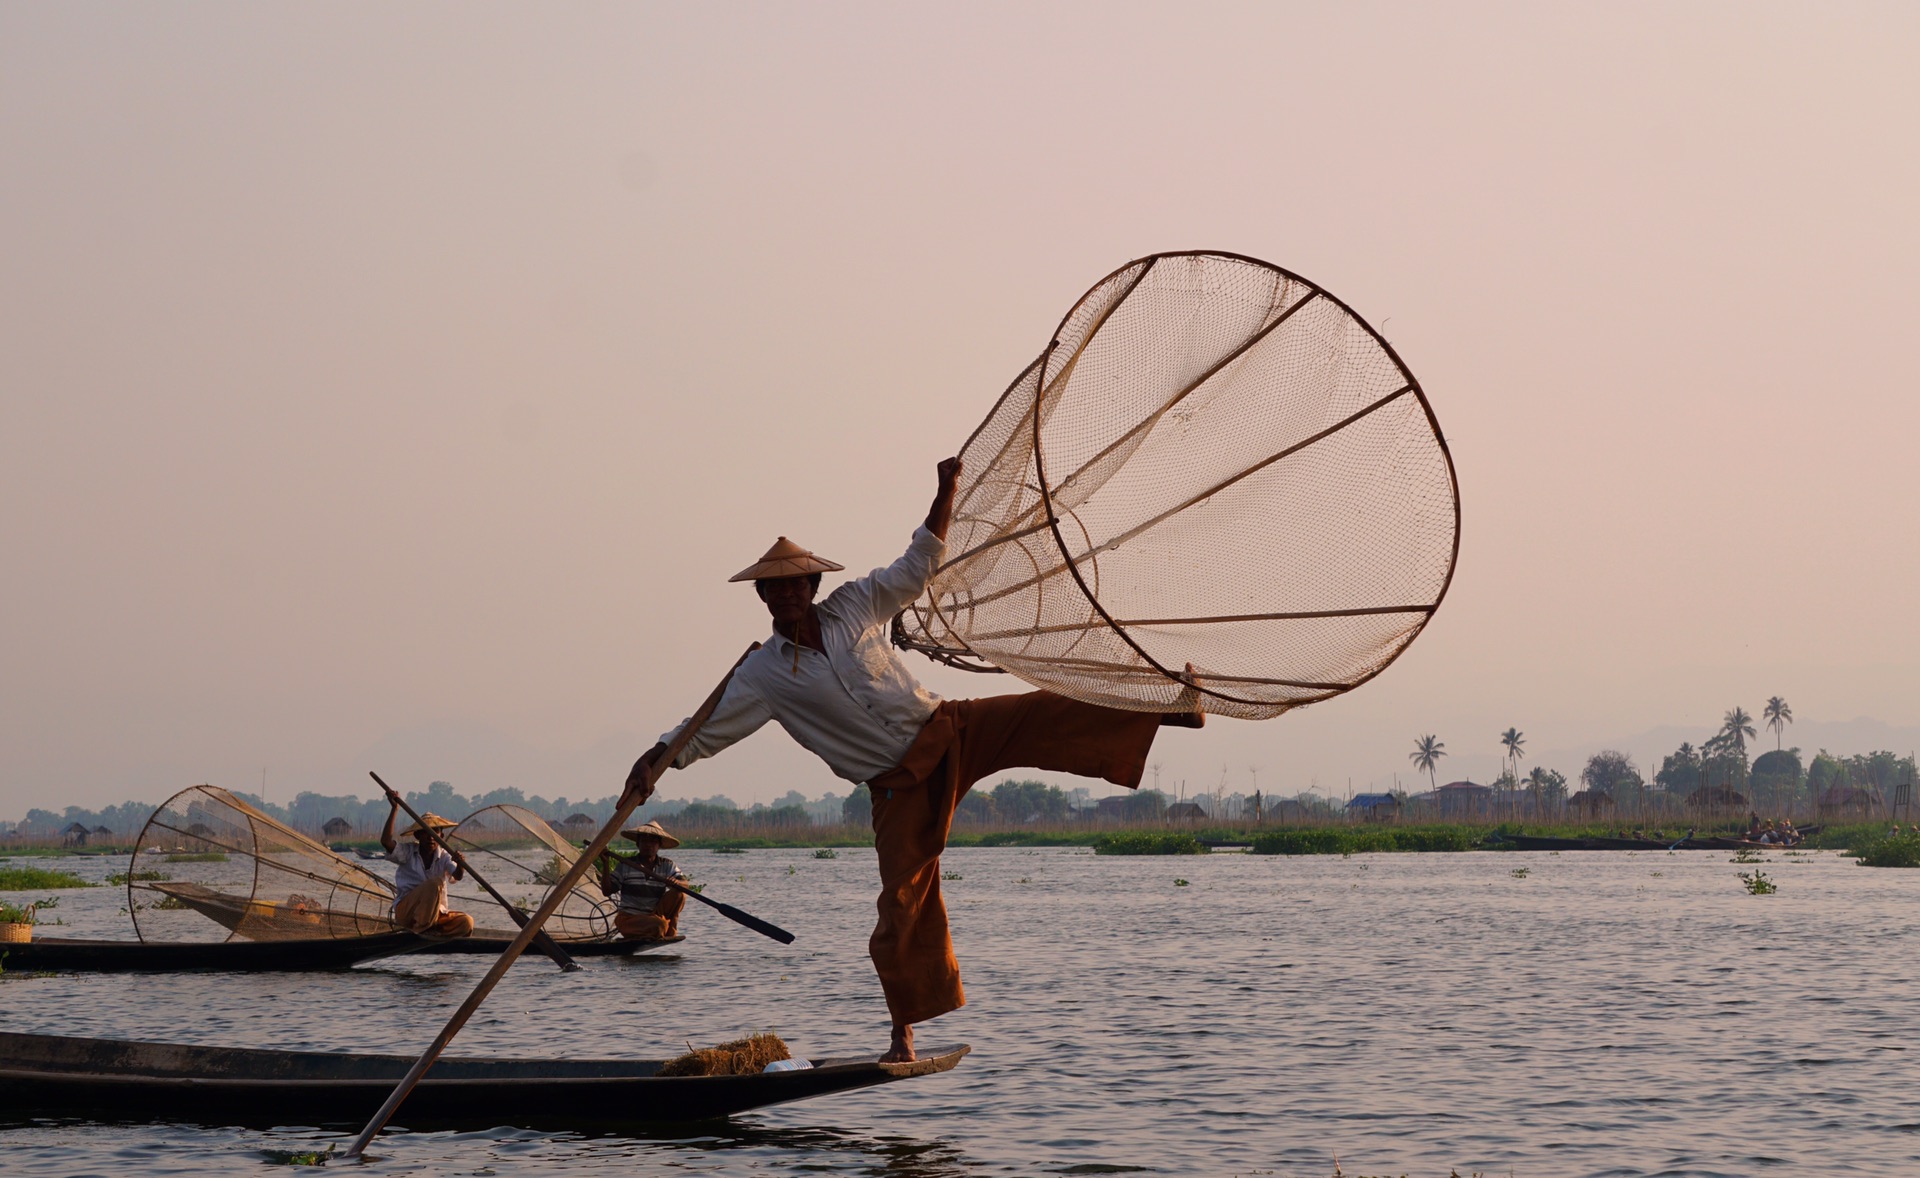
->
[0,850,1920,1178]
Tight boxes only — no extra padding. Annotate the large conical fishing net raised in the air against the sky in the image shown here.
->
[895,253,1459,719]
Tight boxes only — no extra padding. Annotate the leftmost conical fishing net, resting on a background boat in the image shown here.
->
[127,785,394,940]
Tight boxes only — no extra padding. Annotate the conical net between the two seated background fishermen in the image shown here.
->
[447,806,614,940]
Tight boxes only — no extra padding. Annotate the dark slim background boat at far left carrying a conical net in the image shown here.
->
[0,932,436,973]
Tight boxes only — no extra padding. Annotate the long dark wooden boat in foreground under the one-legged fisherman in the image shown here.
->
[0,1032,968,1128]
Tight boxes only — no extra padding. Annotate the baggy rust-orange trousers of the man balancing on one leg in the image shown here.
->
[868,691,1160,1025]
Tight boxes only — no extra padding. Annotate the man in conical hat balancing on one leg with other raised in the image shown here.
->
[628,459,1206,1061]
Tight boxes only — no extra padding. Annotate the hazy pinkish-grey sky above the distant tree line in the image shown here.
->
[0,2,1920,817]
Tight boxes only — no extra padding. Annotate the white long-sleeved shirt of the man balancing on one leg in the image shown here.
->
[660,528,947,781]
